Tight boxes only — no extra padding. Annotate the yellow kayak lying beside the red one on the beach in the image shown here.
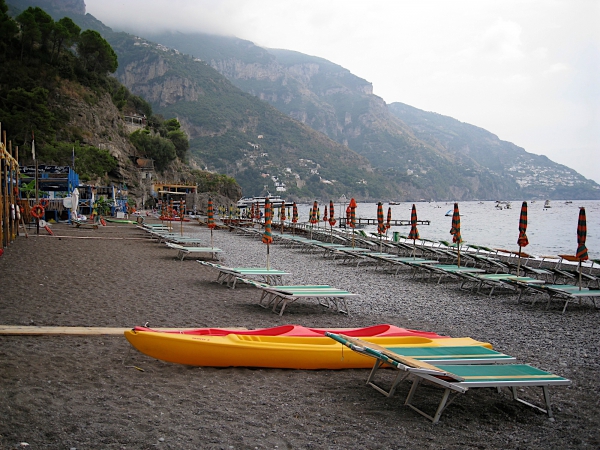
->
[125,330,492,369]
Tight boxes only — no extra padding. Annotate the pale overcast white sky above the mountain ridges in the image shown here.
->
[85,0,600,183]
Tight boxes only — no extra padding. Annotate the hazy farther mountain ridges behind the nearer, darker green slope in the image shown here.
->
[152,33,600,200]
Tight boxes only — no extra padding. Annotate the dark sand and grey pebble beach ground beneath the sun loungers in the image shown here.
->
[0,223,600,450]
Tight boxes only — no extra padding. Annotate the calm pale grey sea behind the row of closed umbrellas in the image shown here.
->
[298,200,600,259]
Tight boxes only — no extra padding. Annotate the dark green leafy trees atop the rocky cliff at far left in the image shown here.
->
[0,0,118,180]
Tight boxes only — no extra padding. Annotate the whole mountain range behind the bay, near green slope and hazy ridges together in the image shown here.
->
[10,0,600,200]
